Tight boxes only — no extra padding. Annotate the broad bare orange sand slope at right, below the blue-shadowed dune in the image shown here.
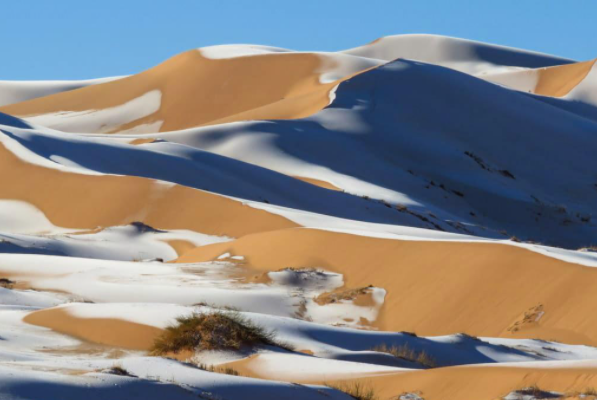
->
[178,229,597,345]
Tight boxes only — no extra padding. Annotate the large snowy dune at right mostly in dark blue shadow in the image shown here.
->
[160,60,597,248]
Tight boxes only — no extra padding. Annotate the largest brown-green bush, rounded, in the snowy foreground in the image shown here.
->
[151,311,289,356]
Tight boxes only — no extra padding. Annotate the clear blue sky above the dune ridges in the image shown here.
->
[0,0,597,80]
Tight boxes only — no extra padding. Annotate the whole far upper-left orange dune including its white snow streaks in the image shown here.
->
[0,45,383,133]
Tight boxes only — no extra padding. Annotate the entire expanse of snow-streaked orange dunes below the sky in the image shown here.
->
[0,35,597,400]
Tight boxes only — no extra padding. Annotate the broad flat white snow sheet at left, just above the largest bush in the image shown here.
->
[0,254,297,316]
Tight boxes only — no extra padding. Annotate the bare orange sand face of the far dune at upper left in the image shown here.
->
[0,50,346,132]
